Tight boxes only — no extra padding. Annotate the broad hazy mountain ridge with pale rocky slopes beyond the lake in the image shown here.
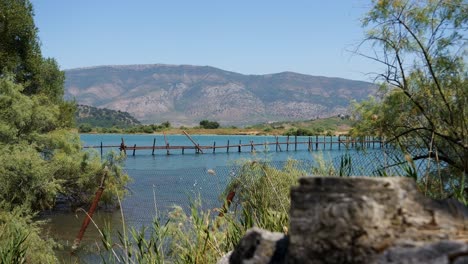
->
[65,64,376,125]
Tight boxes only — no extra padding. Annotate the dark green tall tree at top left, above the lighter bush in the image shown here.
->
[0,0,65,99]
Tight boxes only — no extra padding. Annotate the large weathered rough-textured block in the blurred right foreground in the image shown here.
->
[225,177,468,263]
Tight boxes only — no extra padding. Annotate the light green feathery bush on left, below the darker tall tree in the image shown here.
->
[0,77,126,210]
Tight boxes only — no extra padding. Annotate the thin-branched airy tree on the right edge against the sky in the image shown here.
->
[353,0,468,198]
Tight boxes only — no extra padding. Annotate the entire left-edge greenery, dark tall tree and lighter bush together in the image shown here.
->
[0,0,127,210]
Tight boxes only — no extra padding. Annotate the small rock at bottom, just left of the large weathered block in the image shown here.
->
[228,228,288,264]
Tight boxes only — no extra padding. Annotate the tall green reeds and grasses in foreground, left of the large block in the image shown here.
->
[97,160,307,263]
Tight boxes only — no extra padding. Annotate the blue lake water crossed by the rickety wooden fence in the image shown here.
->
[45,134,392,260]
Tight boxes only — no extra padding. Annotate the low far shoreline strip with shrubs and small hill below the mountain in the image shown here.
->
[76,105,353,136]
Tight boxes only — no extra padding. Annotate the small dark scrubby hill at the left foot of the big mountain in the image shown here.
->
[76,105,141,127]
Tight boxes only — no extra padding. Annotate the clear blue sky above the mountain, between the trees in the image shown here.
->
[32,0,375,80]
